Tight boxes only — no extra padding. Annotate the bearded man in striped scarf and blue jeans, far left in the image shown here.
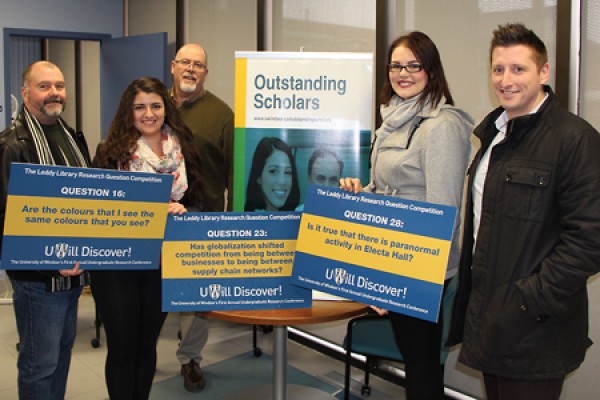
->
[0,61,90,400]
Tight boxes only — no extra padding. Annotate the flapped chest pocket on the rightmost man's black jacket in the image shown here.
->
[502,162,552,221]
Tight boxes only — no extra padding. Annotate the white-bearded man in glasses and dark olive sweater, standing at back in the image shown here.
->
[171,44,233,392]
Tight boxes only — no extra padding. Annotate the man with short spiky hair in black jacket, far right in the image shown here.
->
[449,24,600,400]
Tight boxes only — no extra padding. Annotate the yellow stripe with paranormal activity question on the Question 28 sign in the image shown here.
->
[296,214,450,284]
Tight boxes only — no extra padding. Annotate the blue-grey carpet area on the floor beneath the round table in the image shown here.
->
[150,352,340,400]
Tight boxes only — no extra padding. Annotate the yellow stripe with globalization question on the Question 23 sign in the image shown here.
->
[162,240,296,278]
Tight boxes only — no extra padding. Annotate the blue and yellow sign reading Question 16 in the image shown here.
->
[2,163,173,270]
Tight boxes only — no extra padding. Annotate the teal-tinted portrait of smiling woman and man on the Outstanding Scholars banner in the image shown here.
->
[244,129,370,211]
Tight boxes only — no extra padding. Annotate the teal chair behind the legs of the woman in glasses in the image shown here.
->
[344,276,458,400]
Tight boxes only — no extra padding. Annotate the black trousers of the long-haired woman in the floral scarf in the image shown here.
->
[92,269,167,400]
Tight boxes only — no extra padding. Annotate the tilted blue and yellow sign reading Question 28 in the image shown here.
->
[292,185,456,321]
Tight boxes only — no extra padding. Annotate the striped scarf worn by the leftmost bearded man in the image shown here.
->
[23,106,88,167]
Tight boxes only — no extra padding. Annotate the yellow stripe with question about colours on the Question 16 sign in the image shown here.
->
[4,196,168,239]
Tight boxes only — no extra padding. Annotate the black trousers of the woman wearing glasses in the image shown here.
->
[390,282,448,400]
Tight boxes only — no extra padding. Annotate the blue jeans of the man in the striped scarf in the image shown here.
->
[12,280,81,400]
